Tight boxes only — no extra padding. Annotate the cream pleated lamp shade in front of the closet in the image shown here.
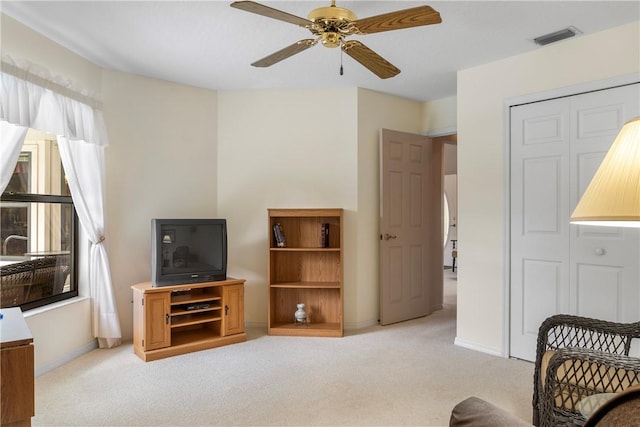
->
[571,117,640,228]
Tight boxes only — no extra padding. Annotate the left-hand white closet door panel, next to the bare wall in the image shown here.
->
[510,98,570,360]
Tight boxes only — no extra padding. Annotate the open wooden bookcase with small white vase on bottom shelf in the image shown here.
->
[267,209,344,337]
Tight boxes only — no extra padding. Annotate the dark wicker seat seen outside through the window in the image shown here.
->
[0,256,71,308]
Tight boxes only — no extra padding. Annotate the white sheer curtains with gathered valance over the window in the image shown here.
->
[0,56,122,348]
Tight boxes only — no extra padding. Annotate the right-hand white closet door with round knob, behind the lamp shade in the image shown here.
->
[569,88,640,322]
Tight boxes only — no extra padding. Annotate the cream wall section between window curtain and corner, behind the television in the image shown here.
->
[103,70,218,340]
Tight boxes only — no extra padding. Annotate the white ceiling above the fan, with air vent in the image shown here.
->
[0,0,640,101]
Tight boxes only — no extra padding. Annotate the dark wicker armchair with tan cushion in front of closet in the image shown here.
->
[533,315,640,427]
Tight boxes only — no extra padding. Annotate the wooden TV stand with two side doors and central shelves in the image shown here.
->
[131,278,247,362]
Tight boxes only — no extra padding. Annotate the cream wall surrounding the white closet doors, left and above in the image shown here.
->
[456,22,640,355]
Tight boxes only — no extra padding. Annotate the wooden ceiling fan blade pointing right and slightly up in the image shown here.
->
[353,6,442,34]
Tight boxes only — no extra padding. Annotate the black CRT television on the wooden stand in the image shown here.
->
[151,218,227,286]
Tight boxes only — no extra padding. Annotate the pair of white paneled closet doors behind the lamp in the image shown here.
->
[510,84,640,360]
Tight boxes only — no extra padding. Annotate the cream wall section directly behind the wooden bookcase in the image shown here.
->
[217,89,357,327]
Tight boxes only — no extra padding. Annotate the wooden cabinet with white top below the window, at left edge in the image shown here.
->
[0,308,35,427]
